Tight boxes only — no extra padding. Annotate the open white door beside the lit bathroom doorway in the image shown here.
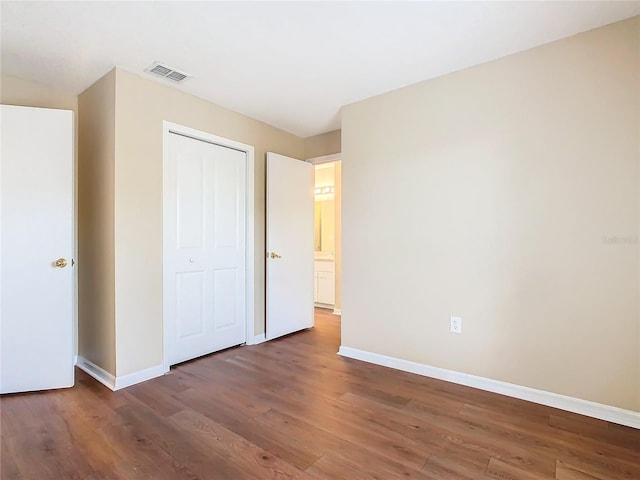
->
[266,152,314,340]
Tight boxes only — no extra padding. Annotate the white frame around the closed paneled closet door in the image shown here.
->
[162,120,255,372]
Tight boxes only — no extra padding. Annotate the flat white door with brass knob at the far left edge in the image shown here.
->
[0,105,75,393]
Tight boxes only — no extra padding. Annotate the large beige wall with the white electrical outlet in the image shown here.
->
[342,17,640,411]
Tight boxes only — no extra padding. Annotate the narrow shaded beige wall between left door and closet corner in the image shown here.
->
[78,71,116,375]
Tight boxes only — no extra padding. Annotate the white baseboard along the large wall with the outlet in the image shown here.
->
[338,346,640,429]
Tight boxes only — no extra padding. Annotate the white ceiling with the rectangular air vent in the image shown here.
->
[0,1,640,137]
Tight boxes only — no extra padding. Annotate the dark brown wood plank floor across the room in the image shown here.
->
[0,309,640,480]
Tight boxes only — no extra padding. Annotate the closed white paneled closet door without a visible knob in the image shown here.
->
[164,133,247,365]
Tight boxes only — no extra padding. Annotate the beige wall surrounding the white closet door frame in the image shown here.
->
[115,69,304,376]
